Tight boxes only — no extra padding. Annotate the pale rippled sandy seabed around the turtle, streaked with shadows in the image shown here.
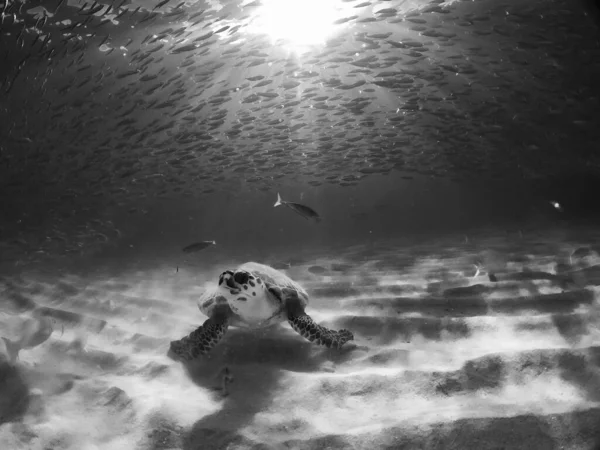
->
[0,234,600,450]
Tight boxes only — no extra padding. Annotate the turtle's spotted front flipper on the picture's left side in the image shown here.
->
[171,317,229,361]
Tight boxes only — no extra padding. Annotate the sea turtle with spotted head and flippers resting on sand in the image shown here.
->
[171,262,354,361]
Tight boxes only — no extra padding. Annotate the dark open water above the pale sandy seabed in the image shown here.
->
[0,1,600,265]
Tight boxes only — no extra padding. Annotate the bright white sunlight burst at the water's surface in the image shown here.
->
[248,0,341,50]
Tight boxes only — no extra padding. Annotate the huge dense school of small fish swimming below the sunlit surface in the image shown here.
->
[0,0,600,264]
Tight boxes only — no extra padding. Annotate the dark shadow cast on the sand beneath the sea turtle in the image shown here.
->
[169,326,355,450]
